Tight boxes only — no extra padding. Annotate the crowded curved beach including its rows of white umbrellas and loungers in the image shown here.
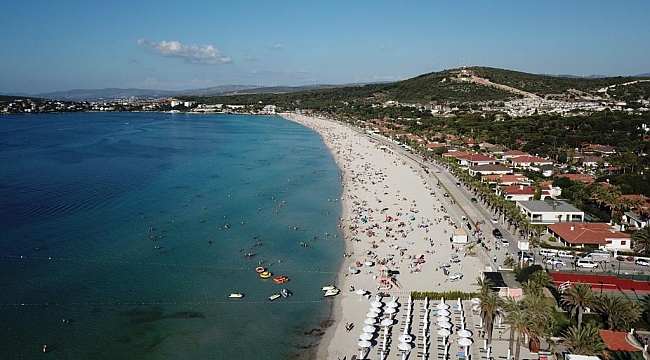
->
[283,113,530,360]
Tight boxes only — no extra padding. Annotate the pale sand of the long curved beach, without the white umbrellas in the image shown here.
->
[281,113,492,359]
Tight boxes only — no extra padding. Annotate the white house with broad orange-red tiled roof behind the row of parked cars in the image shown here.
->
[548,222,631,251]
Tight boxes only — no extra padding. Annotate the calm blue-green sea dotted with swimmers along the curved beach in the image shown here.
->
[0,113,343,360]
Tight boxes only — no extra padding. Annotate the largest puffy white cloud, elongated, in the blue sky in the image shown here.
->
[137,39,232,65]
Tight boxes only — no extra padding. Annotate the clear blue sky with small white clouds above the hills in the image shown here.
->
[0,0,650,94]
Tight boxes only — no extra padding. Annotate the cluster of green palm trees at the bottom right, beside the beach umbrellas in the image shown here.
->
[477,269,650,360]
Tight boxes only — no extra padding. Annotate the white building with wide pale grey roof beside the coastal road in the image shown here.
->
[516,199,585,224]
